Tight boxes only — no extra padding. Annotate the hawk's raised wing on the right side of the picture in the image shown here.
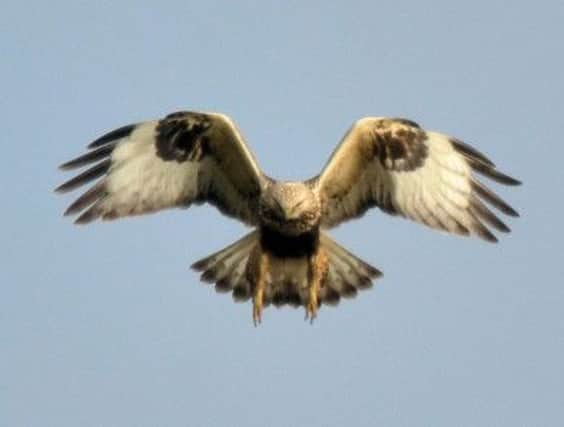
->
[310,117,520,242]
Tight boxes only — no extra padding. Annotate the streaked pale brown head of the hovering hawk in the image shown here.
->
[259,182,321,236]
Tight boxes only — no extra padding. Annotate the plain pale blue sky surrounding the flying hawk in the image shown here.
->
[0,1,564,426]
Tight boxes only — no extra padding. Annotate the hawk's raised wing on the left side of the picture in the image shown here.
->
[56,112,265,224]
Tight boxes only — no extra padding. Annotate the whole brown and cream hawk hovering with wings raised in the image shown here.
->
[56,111,520,325]
